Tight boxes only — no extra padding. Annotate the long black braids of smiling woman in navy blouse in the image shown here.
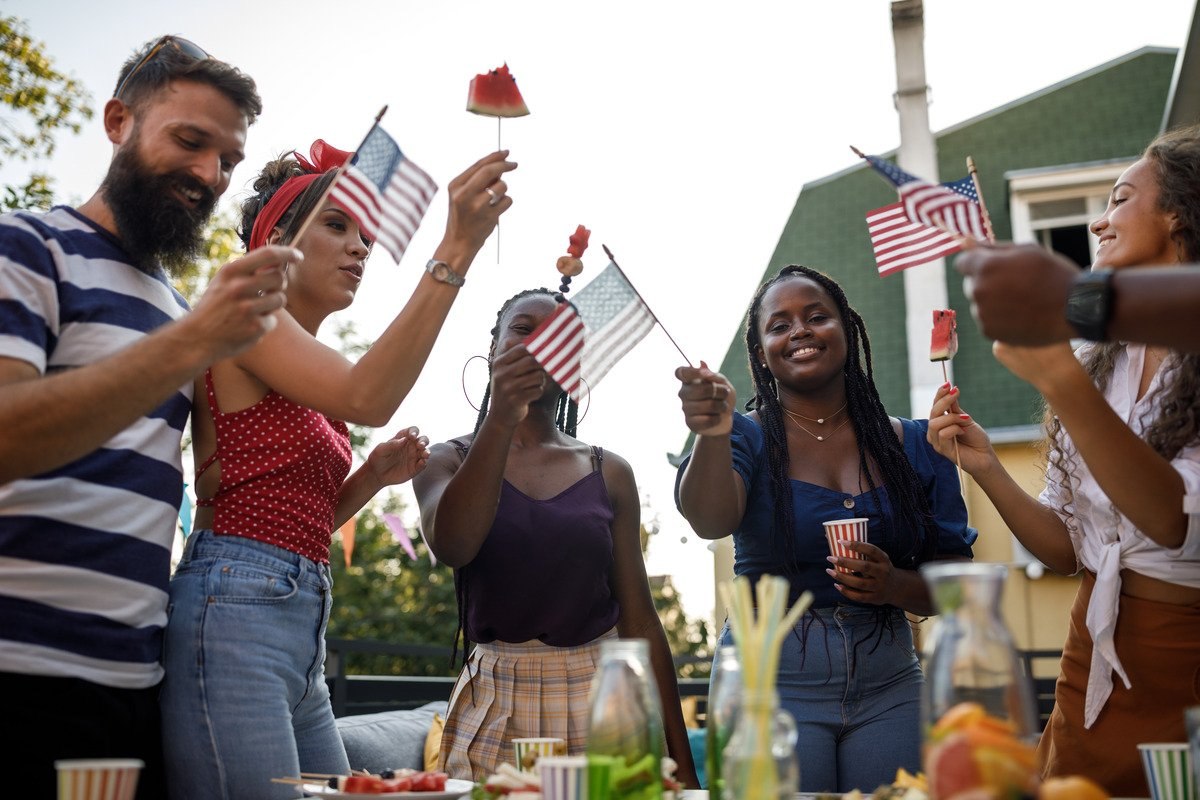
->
[745,265,937,569]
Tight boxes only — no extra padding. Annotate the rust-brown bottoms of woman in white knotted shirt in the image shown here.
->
[1038,572,1200,798]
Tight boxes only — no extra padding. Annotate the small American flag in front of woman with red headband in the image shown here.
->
[329,125,438,261]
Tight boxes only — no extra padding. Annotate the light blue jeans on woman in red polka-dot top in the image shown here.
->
[161,530,349,800]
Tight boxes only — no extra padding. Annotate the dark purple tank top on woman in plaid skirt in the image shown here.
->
[457,447,620,648]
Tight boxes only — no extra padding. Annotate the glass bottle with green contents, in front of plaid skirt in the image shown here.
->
[587,639,665,800]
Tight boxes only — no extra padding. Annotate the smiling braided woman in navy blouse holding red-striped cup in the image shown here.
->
[676,266,976,793]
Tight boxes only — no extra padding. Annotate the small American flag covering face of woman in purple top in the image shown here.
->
[524,263,655,403]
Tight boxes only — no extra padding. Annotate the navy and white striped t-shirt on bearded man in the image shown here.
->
[0,207,192,688]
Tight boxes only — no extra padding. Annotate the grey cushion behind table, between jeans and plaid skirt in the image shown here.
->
[337,700,446,772]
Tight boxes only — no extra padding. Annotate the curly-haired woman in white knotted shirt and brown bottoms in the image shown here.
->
[929,127,1200,796]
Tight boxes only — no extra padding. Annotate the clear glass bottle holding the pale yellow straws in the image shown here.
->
[709,688,800,800]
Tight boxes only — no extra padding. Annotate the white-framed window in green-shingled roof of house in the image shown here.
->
[1004,158,1135,267]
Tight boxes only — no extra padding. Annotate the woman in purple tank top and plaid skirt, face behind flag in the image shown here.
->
[413,289,698,787]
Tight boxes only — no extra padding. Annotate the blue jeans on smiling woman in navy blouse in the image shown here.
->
[721,606,924,794]
